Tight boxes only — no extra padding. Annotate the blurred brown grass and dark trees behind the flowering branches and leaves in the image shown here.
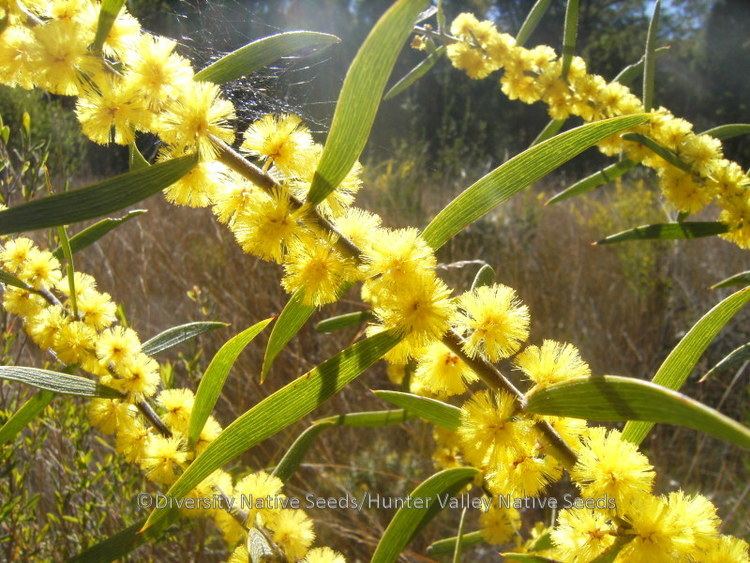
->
[0,0,750,561]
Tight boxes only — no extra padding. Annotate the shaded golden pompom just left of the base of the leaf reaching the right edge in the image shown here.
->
[457,391,532,468]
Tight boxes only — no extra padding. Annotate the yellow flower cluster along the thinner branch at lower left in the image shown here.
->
[0,232,344,563]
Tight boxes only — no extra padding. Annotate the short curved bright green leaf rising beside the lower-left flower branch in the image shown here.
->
[187,318,273,444]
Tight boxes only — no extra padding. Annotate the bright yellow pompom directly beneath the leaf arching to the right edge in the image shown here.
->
[570,427,654,508]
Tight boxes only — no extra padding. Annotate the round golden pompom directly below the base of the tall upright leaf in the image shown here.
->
[281,234,358,307]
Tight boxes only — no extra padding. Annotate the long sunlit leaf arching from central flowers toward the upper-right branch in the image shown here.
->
[422,115,646,250]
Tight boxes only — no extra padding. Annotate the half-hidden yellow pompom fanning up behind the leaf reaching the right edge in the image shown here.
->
[514,340,591,389]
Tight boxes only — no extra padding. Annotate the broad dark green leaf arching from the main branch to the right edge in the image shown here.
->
[526,375,750,448]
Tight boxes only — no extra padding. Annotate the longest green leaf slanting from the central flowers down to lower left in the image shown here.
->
[144,332,400,527]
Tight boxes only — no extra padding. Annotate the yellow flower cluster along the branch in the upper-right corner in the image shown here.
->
[447,13,750,248]
